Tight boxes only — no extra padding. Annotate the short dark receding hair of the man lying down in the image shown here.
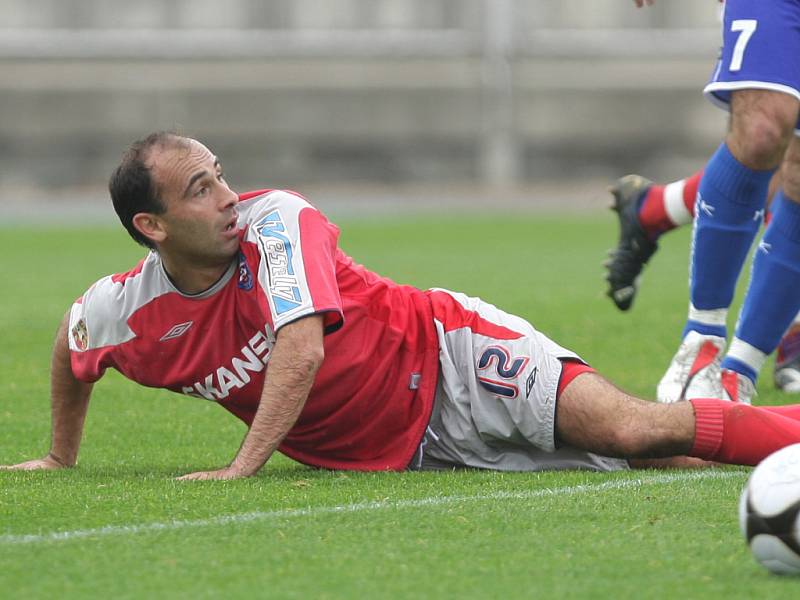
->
[108,131,186,249]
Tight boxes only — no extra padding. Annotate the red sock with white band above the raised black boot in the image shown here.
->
[638,171,703,240]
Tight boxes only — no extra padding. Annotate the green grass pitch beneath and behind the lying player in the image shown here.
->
[0,212,800,599]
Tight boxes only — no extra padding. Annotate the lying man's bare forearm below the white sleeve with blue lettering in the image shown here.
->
[180,315,325,480]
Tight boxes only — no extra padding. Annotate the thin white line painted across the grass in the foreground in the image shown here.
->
[0,471,743,546]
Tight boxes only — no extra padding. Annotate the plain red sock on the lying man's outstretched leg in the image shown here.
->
[689,398,800,465]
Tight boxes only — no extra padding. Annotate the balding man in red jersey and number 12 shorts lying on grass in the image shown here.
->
[1,132,800,479]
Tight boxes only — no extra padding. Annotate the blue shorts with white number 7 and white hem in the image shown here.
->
[703,0,800,132]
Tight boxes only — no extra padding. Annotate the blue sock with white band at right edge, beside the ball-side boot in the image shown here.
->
[722,191,800,381]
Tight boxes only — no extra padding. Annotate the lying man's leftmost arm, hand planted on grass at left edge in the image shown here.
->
[0,313,92,471]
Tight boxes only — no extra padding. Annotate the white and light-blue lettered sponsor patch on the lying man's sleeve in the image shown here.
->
[254,210,303,315]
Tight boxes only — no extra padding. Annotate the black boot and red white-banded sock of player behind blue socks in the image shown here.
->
[605,171,702,310]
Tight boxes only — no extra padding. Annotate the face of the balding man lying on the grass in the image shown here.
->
[147,139,239,267]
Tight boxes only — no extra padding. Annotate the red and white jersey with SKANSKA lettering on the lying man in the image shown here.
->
[69,190,439,470]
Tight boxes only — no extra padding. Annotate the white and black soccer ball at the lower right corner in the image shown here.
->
[739,444,800,575]
